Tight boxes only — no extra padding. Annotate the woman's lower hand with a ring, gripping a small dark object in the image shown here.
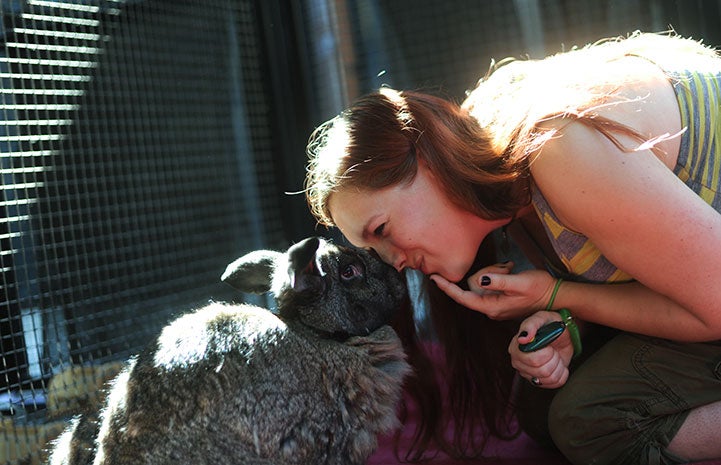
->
[508,311,573,389]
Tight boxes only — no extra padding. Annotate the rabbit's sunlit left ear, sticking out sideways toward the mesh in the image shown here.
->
[220,250,283,294]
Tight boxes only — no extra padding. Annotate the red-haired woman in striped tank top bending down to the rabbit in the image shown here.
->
[306,34,721,464]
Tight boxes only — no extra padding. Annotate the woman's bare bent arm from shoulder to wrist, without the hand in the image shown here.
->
[532,116,721,340]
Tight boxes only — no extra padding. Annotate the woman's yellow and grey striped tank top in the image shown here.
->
[532,64,721,282]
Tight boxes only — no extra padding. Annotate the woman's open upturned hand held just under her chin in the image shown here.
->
[430,263,556,320]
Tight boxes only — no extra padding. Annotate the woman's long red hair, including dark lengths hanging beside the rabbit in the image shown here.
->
[306,88,529,460]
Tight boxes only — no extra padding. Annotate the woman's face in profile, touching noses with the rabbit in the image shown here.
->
[329,166,510,282]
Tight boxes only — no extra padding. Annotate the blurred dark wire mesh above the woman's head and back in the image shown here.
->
[304,0,721,113]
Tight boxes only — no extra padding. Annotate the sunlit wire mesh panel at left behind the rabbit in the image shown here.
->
[0,0,282,463]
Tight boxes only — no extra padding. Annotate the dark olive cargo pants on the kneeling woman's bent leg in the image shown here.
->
[540,333,721,465]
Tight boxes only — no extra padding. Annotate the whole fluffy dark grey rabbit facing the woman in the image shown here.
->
[49,238,409,465]
